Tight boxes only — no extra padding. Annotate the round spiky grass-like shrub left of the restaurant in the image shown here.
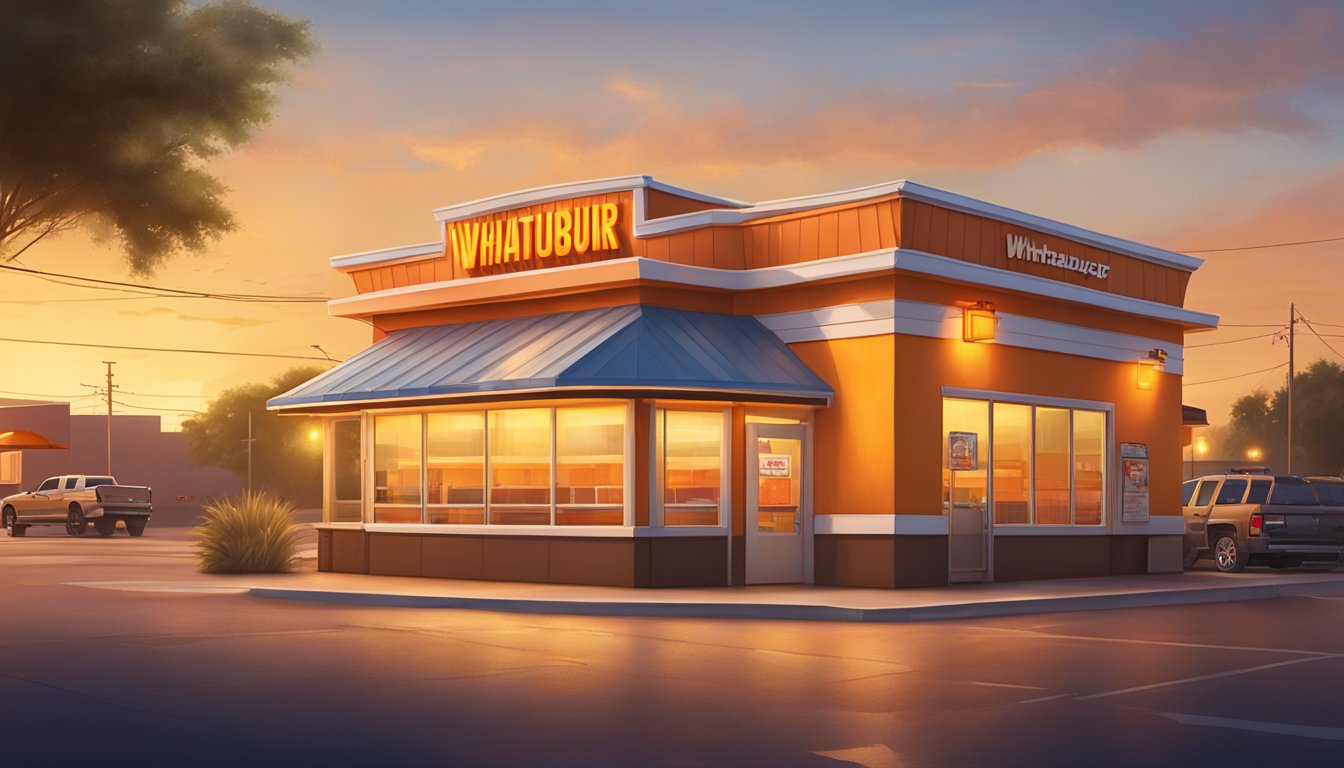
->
[196,491,298,573]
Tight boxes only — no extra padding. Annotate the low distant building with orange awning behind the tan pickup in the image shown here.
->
[0,398,242,510]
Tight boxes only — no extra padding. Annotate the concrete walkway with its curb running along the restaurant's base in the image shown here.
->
[192,570,1344,621]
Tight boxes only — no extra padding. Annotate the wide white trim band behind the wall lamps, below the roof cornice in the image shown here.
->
[757,299,1184,375]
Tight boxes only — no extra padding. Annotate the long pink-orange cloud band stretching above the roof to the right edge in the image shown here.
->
[409,9,1344,174]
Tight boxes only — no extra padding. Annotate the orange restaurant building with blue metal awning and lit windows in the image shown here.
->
[269,176,1218,588]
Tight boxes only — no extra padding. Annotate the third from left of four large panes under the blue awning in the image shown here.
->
[489,408,551,526]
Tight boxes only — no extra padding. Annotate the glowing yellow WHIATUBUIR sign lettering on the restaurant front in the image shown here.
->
[449,203,621,269]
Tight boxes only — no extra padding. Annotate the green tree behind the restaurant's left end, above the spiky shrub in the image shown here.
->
[181,367,323,504]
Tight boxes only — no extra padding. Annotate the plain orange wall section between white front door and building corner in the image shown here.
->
[789,336,899,515]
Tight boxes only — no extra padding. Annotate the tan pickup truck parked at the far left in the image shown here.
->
[0,475,153,537]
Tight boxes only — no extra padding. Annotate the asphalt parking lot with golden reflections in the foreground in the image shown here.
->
[0,526,1344,765]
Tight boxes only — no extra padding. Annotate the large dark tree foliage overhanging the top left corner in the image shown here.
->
[0,0,314,273]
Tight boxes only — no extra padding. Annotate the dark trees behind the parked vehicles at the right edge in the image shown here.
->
[1224,360,1344,475]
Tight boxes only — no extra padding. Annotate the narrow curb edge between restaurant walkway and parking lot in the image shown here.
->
[247,581,1344,623]
